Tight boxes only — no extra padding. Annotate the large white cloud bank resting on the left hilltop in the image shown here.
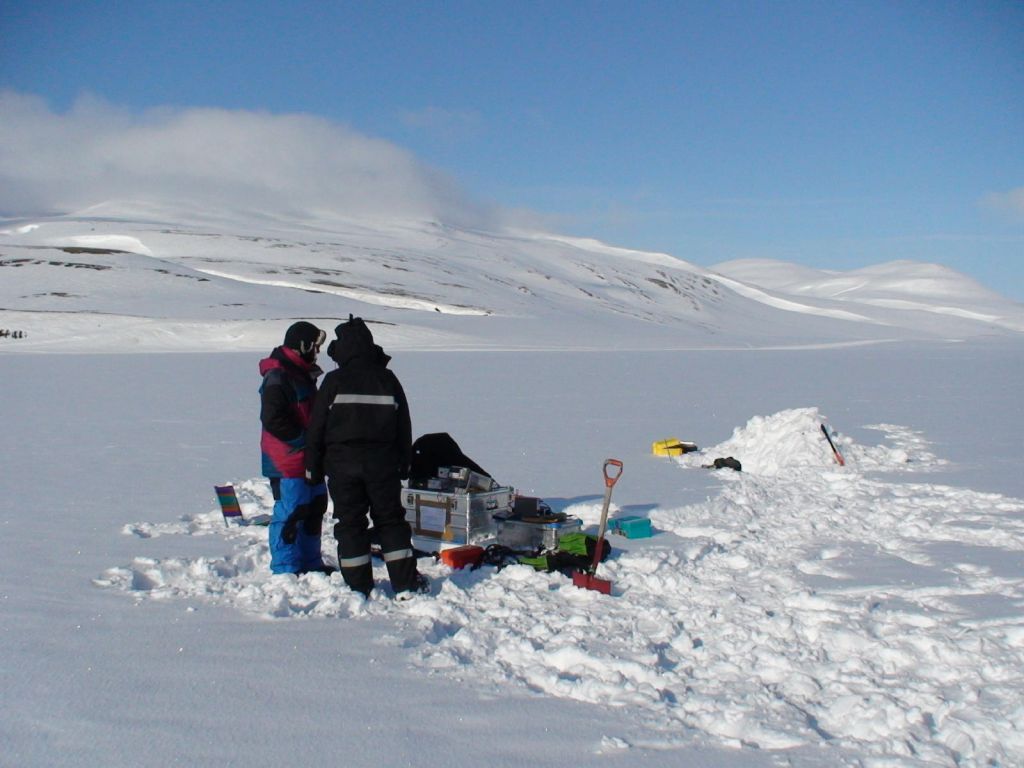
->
[0,91,489,225]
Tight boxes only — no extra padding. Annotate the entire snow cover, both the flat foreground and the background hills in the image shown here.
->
[0,205,1024,766]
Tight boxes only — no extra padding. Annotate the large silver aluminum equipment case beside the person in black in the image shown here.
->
[401,486,515,545]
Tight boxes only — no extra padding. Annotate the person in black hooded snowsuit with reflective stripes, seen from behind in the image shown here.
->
[306,316,429,599]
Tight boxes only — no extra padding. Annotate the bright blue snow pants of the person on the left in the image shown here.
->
[269,477,327,573]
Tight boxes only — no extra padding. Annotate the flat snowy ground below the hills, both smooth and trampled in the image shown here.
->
[0,341,1024,766]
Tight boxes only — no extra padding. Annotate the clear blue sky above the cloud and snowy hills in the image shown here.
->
[0,0,1024,300]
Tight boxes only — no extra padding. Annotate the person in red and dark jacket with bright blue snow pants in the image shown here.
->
[259,322,332,573]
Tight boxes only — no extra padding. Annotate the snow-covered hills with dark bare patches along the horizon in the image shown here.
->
[0,204,1024,351]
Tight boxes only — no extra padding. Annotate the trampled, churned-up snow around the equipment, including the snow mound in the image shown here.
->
[97,409,1024,766]
